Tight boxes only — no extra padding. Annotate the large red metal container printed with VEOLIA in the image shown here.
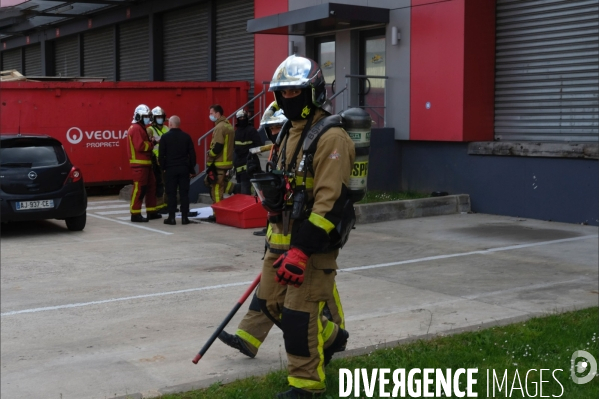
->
[0,81,250,185]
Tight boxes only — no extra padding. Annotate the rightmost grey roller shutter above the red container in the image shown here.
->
[216,0,254,98]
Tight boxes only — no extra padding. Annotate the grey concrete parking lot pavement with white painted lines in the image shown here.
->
[0,198,599,399]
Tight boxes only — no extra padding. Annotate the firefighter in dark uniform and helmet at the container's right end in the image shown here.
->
[234,110,263,195]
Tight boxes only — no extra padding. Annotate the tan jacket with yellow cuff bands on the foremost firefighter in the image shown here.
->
[266,109,356,255]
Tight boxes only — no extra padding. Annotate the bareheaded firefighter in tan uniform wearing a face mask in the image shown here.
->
[204,104,235,203]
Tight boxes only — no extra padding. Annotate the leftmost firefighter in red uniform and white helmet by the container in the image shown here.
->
[127,104,162,222]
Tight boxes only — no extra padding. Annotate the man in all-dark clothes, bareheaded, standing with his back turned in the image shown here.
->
[158,115,196,225]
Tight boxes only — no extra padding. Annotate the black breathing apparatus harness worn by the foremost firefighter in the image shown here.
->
[251,114,356,250]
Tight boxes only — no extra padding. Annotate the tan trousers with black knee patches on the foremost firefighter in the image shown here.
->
[257,251,339,392]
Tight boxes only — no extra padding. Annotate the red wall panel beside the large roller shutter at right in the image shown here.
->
[410,0,495,141]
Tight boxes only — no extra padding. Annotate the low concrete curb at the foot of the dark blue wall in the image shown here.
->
[355,194,470,224]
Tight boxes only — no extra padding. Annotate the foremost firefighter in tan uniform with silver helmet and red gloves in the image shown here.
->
[234,56,355,398]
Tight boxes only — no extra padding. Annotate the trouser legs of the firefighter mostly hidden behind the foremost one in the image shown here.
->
[236,280,345,355]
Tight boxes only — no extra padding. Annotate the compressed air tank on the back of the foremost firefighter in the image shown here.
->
[341,108,372,202]
